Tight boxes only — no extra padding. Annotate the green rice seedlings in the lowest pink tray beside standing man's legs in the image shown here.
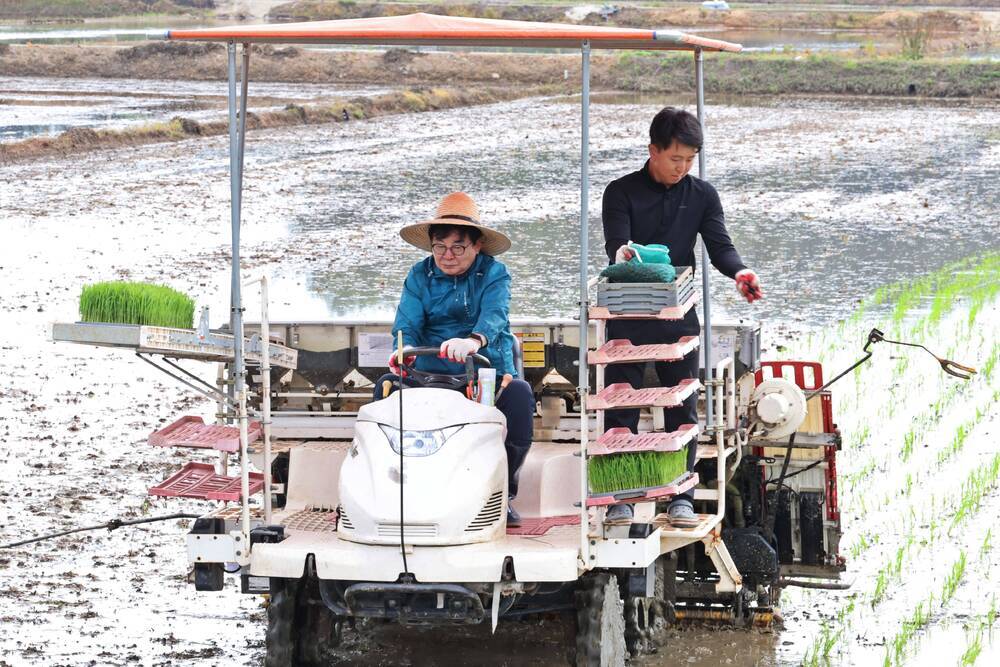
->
[587,447,687,493]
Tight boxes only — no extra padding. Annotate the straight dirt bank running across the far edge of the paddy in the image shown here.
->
[0,42,1000,98]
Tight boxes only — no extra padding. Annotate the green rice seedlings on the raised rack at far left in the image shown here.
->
[80,282,194,329]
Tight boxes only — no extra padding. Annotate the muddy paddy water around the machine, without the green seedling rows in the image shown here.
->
[0,91,1000,665]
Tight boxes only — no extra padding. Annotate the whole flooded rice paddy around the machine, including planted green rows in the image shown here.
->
[0,87,1000,666]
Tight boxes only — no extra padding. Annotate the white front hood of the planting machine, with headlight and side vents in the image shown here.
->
[338,387,507,545]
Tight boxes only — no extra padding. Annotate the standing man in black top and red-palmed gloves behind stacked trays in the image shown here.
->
[601,107,763,527]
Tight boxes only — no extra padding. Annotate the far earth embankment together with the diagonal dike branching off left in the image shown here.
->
[0,42,1000,163]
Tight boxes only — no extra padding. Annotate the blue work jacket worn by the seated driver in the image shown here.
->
[392,253,517,376]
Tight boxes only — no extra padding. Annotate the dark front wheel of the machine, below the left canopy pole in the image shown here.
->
[264,579,342,667]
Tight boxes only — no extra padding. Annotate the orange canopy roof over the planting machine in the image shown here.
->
[167,13,743,51]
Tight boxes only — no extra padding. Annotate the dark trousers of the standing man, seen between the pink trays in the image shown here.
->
[604,309,701,500]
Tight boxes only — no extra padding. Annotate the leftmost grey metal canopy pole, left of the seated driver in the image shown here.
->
[227,41,250,565]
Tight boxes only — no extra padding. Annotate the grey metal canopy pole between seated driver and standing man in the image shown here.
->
[577,41,591,570]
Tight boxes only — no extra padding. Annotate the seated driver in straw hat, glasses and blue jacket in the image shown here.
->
[376,192,535,525]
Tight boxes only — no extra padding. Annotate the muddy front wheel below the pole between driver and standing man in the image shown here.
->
[575,572,626,667]
